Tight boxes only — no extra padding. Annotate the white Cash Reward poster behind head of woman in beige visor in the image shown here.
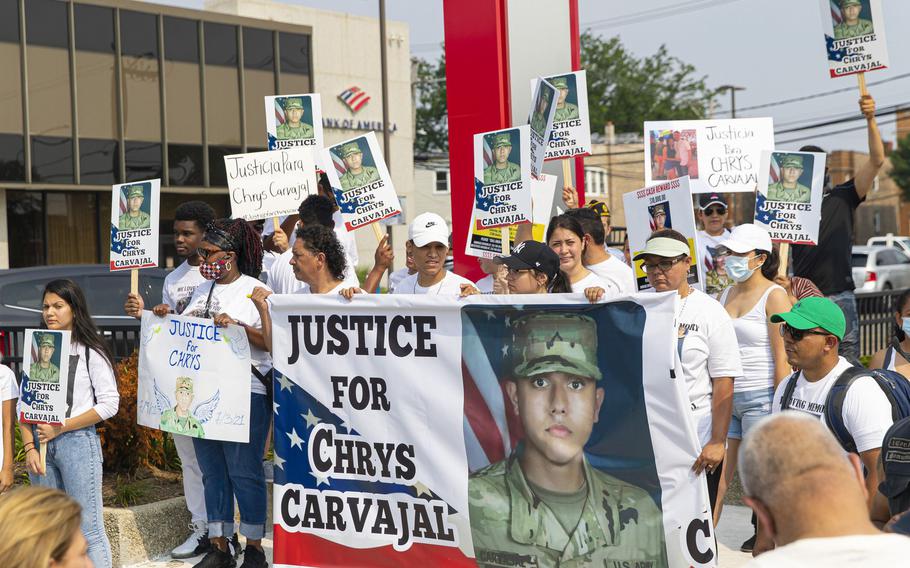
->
[622,176,704,290]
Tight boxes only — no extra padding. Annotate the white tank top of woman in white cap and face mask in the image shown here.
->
[720,284,783,392]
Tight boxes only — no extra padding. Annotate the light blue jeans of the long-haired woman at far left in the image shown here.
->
[28,426,112,568]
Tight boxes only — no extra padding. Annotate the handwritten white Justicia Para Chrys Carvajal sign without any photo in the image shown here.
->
[224,147,317,221]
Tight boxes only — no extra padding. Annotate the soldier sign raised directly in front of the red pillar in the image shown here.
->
[474,125,531,230]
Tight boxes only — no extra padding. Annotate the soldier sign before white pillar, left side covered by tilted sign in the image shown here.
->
[531,71,591,160]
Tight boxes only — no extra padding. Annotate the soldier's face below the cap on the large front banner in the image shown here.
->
[506,371,604,465]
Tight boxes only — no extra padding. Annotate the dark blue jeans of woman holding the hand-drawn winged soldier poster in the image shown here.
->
[193,393,272,540]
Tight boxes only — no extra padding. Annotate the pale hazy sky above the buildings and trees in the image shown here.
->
[146,0,910,151]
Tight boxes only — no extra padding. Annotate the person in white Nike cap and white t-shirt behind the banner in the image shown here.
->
[392,213,475,296]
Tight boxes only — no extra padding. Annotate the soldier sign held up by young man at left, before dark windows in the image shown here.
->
[110,179,161,270]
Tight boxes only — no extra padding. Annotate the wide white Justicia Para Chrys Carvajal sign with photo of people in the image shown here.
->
[645,118,774,193]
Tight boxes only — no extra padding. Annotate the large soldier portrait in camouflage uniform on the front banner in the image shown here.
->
[468,313,667,568]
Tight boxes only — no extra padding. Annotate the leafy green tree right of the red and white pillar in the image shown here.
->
[581,32,714,132]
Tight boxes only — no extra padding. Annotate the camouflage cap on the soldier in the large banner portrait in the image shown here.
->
[512,314,602,381]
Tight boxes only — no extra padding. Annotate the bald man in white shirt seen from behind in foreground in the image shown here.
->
[739,410,910,568]
